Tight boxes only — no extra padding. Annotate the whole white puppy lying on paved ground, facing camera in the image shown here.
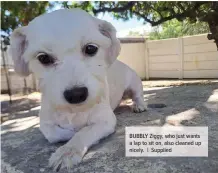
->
[11,9,146,169]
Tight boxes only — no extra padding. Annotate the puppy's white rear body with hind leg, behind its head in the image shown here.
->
[107,60,146,112]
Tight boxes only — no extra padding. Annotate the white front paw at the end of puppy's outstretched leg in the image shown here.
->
[49,145,83,171]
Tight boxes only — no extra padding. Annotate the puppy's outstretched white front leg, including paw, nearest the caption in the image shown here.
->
[49,106,116,170]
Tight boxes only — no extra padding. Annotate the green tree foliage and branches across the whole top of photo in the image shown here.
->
[1,1,218,47]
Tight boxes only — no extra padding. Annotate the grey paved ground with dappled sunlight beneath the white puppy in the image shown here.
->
[1,82,218,173]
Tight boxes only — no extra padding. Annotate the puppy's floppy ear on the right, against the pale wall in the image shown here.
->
[95,18,121,64]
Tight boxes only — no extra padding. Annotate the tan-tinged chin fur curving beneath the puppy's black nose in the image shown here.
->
[54,90,105,113]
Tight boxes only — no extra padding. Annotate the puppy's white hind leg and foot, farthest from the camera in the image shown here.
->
[128,73,147,113]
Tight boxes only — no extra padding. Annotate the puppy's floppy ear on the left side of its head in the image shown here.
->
[10,27,30,76]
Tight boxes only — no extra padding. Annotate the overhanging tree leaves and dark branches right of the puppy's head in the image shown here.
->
[72,1,218,49]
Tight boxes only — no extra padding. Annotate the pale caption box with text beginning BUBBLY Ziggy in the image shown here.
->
[125,126,208,157]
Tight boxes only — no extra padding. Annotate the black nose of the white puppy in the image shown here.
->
[64,87,88,104]
